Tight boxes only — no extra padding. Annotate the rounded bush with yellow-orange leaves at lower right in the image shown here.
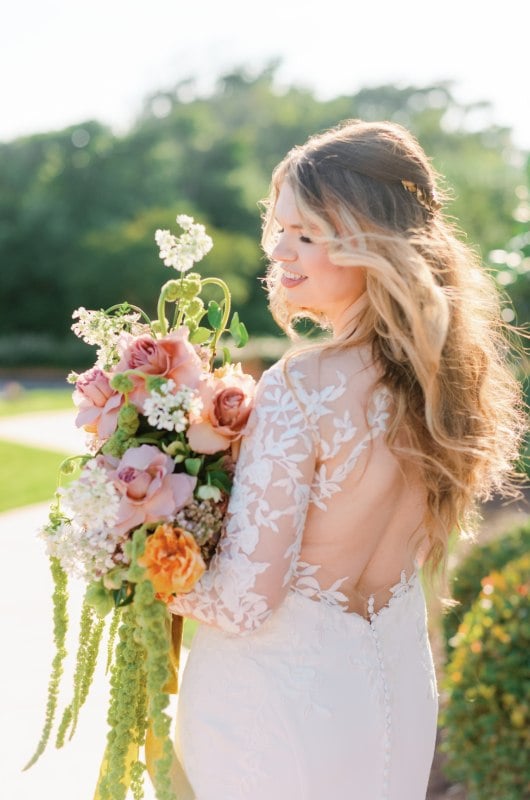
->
[440,553,530,800]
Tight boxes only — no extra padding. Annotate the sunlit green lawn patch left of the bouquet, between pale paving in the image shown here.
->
[0,441,71,511]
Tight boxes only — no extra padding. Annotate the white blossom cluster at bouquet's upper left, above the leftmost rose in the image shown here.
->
[72,306,146,369]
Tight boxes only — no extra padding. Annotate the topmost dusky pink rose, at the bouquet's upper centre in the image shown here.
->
[115,327,204,409]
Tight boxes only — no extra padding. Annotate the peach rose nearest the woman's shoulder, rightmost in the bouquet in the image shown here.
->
[187,364,256,454]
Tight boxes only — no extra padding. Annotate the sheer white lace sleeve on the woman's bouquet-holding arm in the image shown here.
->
[169,364,315,633]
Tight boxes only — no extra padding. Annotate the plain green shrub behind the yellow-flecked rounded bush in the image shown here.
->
[442,522,530,658]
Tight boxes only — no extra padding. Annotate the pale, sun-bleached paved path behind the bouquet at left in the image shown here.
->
[0,411,185,800]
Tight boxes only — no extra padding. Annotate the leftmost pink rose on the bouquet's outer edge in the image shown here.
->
[72,367,122,440]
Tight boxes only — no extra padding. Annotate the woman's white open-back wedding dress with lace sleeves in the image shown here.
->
[172,351,438,800]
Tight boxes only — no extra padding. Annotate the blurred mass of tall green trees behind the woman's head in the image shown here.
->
[0,64,530,368]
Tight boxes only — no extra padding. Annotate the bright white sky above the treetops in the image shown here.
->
[4,0,530,150]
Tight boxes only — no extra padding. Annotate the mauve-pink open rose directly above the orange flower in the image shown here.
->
[105,444,197,534]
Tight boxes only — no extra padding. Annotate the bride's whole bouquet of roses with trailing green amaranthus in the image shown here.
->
[26,215,255,800]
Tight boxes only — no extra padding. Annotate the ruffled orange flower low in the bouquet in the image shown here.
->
[138,523,206,600]
